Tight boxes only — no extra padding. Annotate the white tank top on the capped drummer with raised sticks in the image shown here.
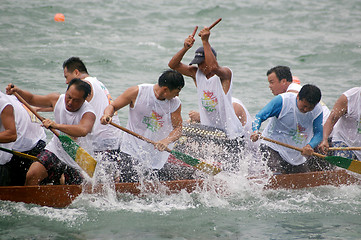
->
[196,69,244,139]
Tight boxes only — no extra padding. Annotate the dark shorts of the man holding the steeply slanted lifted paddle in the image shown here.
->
[38,150,84,185]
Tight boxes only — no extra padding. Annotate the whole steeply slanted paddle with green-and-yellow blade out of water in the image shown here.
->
[14,92,97,177]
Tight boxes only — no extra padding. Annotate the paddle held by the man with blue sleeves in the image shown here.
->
[260,136,361,174]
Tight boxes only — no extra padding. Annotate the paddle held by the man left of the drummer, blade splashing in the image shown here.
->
[109,121,222,175]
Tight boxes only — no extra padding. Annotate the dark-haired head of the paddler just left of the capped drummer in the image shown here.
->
[158,69,184,100]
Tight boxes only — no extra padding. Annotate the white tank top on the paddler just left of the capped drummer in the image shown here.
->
[121,84,181,169]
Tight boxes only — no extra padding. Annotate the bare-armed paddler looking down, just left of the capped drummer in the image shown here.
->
[101,70,184,181]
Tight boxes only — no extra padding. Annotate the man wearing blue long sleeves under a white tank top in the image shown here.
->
[251,84,323,174]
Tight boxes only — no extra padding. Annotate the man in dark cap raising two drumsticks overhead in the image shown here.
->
[168,27,245,139]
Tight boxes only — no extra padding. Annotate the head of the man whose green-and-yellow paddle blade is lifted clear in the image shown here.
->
[65,78,91,112]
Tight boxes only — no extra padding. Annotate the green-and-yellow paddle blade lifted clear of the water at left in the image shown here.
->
[59,135,97,177]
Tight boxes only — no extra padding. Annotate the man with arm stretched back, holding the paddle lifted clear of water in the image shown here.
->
[6,78,96,185]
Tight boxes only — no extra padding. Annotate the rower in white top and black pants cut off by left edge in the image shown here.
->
[0,92,46,186]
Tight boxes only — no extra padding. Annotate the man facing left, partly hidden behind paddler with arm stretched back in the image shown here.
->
[63,57,121,158]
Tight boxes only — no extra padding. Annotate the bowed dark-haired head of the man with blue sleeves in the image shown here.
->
[297,84,321,113]
